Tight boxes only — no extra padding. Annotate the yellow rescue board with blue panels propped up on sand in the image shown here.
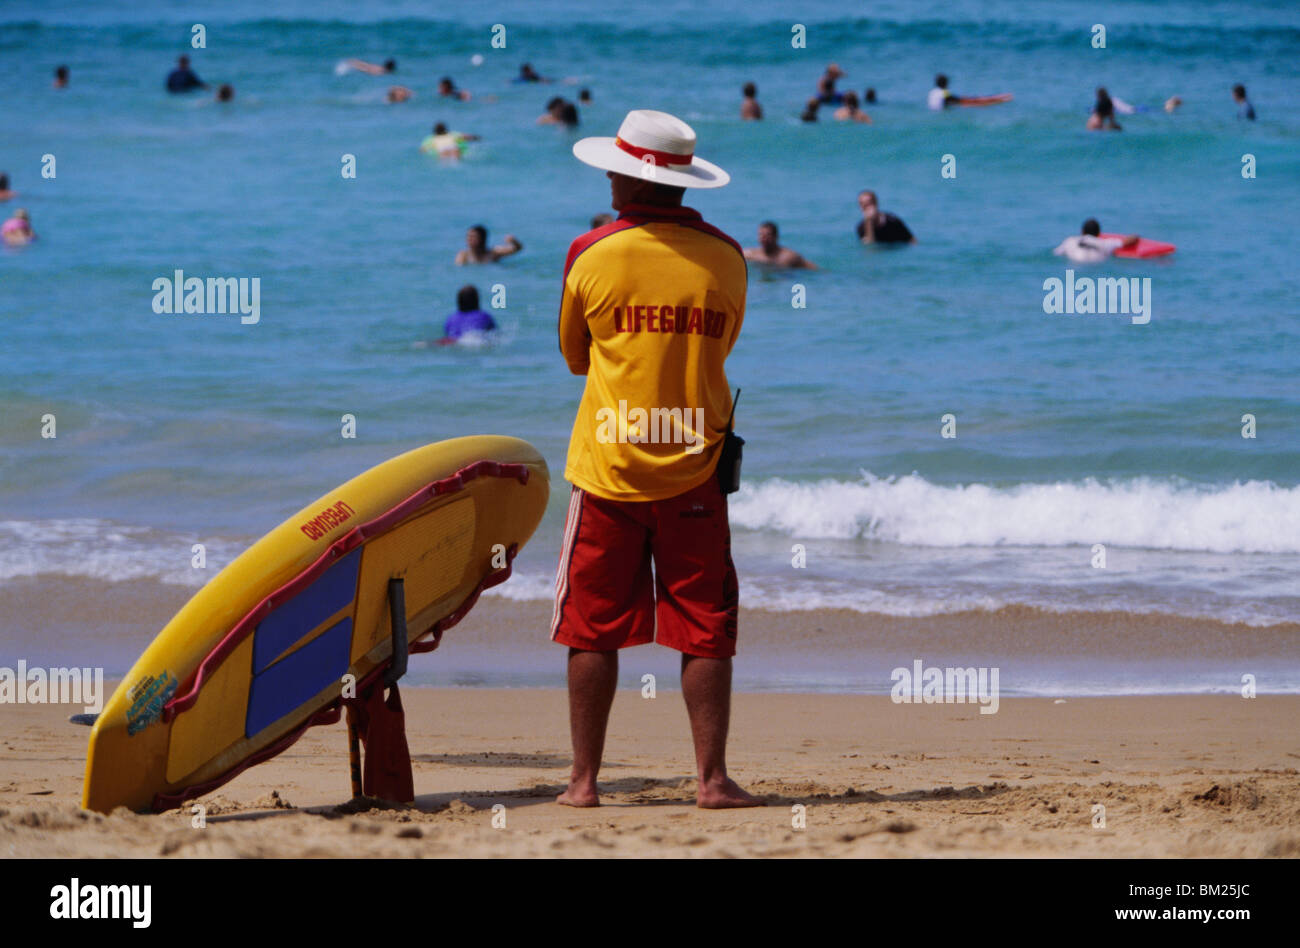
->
[82,436,550,813]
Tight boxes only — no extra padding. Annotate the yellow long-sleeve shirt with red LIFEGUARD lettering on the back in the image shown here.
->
[559,204,748,501]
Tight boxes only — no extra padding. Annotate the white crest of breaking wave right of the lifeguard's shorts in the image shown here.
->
[731,472,1300,553]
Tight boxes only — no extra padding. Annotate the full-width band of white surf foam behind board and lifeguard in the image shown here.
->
[0,491,1300,625]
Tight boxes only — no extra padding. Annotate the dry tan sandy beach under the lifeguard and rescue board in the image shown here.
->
[0,688,1300,857]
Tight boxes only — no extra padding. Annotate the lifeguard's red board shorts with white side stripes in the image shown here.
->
[551,477,740,658]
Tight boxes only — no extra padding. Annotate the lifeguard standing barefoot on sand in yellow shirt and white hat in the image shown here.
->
[551,111,762,808]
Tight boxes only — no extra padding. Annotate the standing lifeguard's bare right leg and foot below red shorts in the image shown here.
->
[681,654,763,809]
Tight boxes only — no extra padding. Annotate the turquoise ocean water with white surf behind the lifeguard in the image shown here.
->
[0,0,1300,691]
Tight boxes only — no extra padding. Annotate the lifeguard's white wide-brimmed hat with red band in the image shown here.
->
[573,109,731,187]
